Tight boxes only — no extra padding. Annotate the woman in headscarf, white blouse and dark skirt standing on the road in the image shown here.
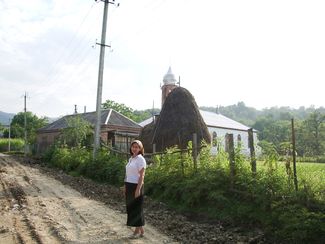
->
[125,140,147,238]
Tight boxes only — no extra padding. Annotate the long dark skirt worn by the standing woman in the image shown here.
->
[125,182,144,227]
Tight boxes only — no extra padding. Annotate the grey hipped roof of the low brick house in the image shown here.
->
[39,109,141,131]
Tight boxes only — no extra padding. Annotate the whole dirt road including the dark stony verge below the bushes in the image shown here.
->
[0,156,266,244]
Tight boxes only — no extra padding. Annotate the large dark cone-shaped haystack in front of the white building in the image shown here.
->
[151,87,211,151]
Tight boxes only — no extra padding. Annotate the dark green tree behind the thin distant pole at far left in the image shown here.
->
[4,112,48,144]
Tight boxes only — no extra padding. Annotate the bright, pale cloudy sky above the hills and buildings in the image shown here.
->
[0,0,325,117]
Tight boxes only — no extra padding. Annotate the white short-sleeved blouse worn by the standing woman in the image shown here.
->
[125,154,147,184]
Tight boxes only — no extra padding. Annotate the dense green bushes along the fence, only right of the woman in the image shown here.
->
[146,144,325,243]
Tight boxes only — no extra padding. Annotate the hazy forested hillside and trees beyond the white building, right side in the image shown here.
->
[201,102,325,162]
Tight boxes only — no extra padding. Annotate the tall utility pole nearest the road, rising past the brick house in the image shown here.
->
[93,0,115,159]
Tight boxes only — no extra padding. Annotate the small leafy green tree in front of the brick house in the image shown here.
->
[60,115,93,147]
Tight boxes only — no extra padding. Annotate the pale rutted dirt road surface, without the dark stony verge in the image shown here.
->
[0,154,172,243]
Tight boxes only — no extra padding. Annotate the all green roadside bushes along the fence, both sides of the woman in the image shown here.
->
[45,140,325,243]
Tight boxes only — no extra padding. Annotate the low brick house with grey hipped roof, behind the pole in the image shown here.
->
[37,109,141,153]
